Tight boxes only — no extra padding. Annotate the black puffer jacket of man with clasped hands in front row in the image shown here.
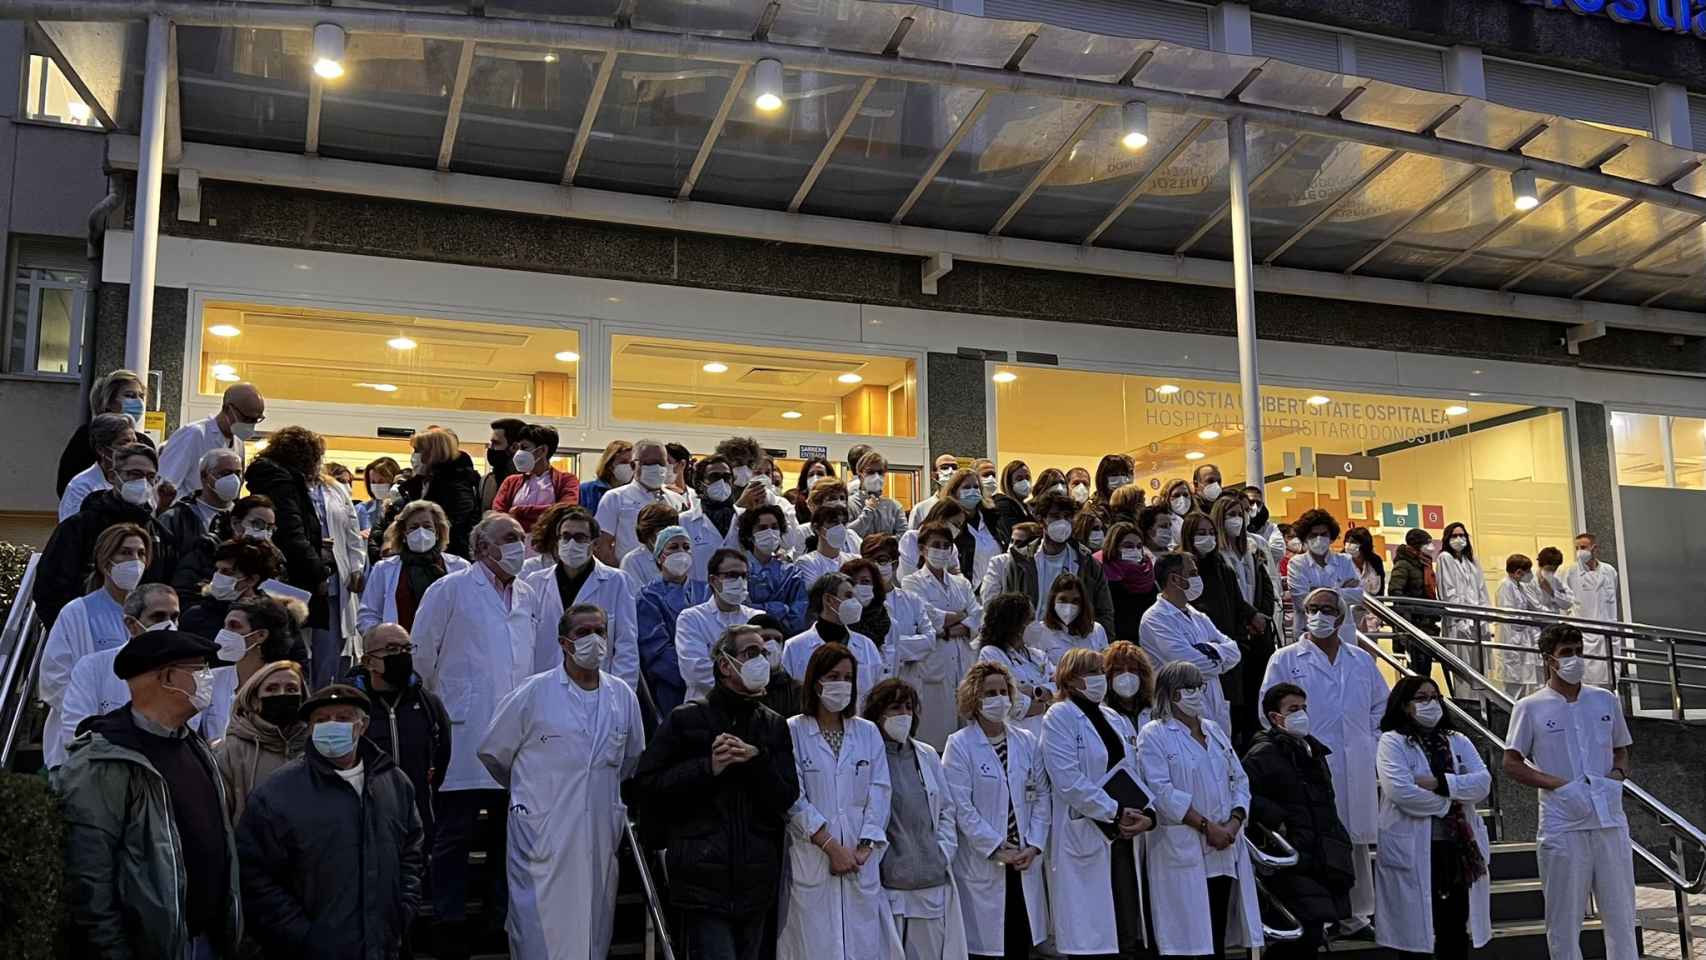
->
[624,684,800,914]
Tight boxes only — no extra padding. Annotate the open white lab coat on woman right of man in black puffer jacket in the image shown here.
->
[776,714,902,960]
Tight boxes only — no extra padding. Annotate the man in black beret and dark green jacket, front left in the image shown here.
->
[55,629,242,960]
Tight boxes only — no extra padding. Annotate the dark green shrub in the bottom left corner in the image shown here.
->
[0,772,65,960]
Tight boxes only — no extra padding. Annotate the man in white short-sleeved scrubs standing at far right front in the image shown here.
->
[1505,624,1636,960]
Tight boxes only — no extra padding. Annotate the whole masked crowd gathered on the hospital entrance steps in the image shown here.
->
[34,370,1634,960]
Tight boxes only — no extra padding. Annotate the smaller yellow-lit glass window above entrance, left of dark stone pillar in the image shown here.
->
[611,334,918,437]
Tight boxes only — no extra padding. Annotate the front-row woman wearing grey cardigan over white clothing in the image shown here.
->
[863,677,966,960]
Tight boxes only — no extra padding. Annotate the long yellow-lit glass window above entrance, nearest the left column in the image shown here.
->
[200,302,580,419]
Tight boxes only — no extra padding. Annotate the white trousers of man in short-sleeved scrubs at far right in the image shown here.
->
[1539,827,1636,960]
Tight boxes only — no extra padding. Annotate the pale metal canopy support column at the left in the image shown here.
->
[125,15,171,379]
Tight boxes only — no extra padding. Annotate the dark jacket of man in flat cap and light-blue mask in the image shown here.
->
[237,740,425,960]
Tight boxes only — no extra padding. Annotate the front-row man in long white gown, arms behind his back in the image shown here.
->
[479,604,645,960]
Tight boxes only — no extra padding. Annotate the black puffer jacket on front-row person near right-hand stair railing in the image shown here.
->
[1244,730,1353,924]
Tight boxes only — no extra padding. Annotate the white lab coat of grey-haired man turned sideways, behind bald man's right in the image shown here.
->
[411,563,534,789]
